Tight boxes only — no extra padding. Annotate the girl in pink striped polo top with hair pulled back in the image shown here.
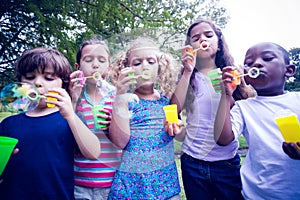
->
[71,39,121,199]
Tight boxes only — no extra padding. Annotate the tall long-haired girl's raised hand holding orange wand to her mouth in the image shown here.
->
[181,45,196,73]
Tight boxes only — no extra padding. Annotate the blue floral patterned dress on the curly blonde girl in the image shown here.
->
[108,96,180,199]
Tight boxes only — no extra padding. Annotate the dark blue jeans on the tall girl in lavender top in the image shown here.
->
[180,153,244,200]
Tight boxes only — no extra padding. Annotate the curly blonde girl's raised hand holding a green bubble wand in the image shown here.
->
[116,67,137,95]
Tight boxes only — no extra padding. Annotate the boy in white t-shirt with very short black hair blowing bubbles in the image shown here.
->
[214,43,300,199]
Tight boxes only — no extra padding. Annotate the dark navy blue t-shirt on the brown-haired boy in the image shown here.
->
[0,112,77,200]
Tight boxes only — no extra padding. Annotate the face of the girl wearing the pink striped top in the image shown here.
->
[79,44,110,83]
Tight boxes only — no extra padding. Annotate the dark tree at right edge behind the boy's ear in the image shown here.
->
[285,48,300,91]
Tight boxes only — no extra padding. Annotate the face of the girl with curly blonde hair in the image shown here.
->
[128,48,159,87]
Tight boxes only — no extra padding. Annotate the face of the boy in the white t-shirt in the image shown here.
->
[244,43,287,95]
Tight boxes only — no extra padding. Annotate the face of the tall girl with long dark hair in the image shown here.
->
[190,22,219,58]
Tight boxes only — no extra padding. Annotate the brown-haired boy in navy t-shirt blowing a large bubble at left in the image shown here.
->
[0,47,100,200]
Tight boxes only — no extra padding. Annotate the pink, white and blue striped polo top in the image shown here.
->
[74,96,122,188]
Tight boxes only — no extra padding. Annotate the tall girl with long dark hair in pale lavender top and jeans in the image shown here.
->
[171,19,252,200]
